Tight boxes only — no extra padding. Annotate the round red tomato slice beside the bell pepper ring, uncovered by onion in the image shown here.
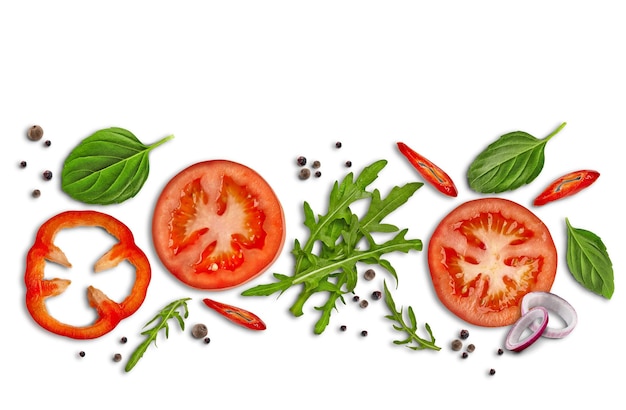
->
[152,160,285,290]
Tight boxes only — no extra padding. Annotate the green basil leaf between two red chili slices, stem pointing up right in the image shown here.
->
[467,123,566,193]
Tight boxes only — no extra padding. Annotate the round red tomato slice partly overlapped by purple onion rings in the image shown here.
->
[428,198,557,327]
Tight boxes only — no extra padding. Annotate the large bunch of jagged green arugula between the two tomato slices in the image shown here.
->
[242,160,423,334]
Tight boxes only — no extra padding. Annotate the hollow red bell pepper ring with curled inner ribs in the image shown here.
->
[24,211,151,339]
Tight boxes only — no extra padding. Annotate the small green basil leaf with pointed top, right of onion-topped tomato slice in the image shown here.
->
[565,218,615,299]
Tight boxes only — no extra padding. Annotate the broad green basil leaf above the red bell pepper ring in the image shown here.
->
[61,128,174,205]
